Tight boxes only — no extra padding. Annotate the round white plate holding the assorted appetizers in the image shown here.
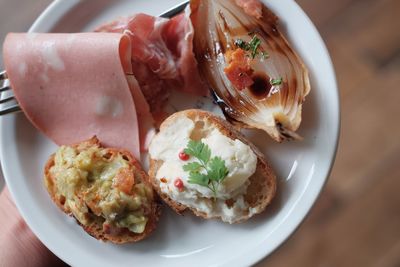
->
[0,0,339,266]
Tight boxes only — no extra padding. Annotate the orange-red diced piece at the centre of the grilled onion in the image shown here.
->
[224,48,254,90]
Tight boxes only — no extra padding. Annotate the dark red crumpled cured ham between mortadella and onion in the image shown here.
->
[96,7,208,114]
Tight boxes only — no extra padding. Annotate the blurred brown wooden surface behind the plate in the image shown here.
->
[0,0,400,267]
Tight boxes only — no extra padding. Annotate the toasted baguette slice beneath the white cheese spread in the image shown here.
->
[149,109,276,223]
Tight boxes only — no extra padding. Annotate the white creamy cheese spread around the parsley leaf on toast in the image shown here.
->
[149,117,257,222]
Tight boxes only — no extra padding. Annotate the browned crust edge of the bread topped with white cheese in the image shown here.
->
[149,109,277,223]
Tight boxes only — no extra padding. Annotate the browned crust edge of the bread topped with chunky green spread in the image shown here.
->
[44,137,161,244]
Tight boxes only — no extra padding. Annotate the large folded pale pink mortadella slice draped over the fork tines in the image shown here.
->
[3,33,140,159]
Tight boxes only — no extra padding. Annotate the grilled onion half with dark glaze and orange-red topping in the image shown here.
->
[190,0,310,142]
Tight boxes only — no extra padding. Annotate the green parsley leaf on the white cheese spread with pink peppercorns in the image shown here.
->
[183,140,229,199]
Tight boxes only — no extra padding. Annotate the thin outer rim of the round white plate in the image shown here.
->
[0,0,341,266]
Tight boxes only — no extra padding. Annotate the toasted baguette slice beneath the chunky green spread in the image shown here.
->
[44,137,161,244]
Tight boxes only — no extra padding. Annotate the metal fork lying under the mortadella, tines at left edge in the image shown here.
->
[0,1,189,116]
